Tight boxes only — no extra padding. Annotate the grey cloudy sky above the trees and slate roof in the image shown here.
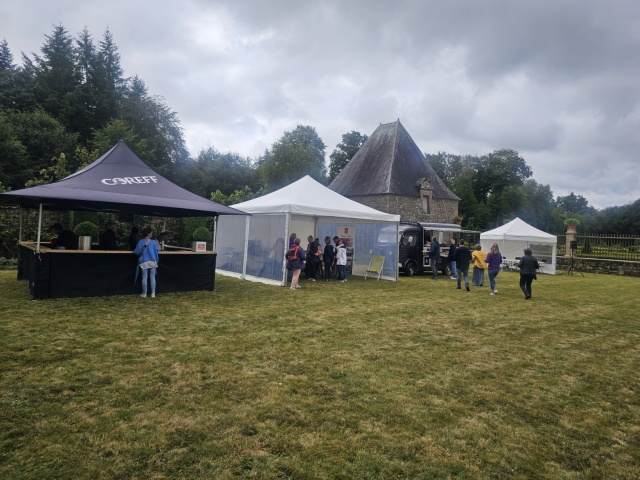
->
[0,0,640,208]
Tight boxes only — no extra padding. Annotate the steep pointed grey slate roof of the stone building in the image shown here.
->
[329,120,460,200]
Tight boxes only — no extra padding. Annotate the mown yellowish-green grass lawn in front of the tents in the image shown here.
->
[0,271,640,479]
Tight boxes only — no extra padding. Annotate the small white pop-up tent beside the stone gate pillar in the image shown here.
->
[480,218,557,274]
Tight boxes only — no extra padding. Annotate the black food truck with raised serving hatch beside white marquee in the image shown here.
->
[377,222,480,276]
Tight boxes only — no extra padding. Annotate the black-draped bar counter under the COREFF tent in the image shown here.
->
[18,242,216,299]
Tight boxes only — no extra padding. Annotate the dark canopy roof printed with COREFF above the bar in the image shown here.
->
[0,140,244,217]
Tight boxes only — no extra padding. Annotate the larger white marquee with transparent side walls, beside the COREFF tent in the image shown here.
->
[216,176,400,285]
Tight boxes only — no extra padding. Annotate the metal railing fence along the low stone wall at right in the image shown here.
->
[556,234,640,261]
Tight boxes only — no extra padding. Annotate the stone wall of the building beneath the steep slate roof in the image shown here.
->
[349,195,458,223]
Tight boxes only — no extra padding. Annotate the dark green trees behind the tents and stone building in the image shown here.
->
[0,25,640,251]
